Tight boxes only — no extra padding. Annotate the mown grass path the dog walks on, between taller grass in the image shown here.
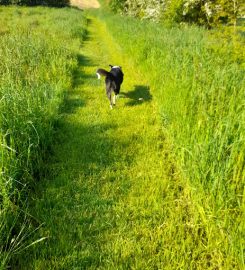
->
[22,18,168,269]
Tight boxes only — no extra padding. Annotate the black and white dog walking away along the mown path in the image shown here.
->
[96,65,124,109]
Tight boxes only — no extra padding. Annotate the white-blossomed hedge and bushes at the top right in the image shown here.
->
[109,0,245,27]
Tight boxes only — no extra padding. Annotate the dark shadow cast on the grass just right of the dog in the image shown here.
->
[121,85,152,106]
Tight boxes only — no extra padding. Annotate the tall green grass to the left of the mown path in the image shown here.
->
[0,7,86,268]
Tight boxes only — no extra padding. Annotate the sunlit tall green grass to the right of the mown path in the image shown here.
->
[94,10,245,269]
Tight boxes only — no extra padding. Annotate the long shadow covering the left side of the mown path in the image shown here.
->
[11,38,135,270]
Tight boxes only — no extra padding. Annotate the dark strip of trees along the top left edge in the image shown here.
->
[0,0,70,7]
